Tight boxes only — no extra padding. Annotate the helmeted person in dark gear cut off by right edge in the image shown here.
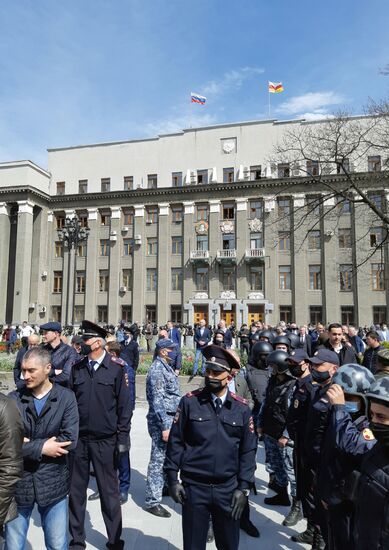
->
[355,376,389,550]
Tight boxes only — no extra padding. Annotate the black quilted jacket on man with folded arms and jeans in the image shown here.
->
[10,384,78,506]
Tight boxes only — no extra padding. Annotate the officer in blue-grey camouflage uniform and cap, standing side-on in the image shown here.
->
[145,338,180,518]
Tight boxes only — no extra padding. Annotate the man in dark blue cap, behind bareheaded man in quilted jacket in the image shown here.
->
[39,322,80,386]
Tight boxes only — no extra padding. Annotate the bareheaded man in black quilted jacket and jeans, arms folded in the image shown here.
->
[5,348,78,550]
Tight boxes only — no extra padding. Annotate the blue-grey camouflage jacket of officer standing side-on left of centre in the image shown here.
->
[146,357,181,431]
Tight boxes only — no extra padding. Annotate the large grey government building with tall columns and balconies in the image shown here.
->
[0,120,389,326]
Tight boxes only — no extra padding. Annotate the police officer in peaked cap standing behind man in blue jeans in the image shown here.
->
[69,321,132,550]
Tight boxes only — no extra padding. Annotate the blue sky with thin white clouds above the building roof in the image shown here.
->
[0,0,389,168]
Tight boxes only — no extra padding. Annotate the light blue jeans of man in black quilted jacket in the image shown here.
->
[4,498,68,550]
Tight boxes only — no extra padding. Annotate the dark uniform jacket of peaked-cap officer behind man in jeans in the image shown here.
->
[70,353,132,448]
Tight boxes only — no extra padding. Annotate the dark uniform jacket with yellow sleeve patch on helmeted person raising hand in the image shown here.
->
[317,405,376,506]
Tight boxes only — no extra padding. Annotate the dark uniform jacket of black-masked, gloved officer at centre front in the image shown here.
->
[165,390,257,489]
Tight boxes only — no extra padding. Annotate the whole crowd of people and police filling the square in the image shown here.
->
[0,320,389,550]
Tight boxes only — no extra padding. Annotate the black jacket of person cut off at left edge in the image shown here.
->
[0,393,23,529]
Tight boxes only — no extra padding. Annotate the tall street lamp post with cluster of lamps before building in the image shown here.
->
[57,216,89,325]
